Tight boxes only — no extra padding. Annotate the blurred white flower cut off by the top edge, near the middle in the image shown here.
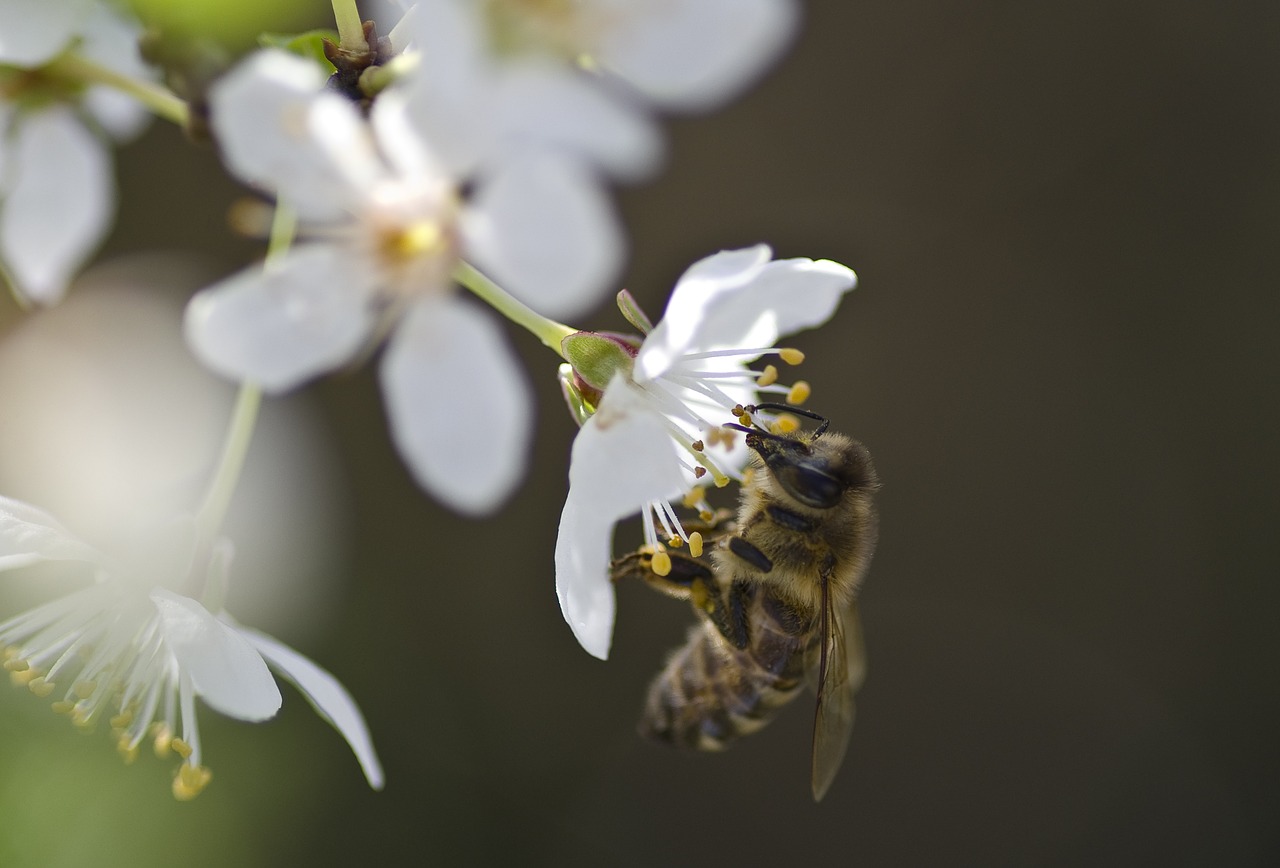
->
[398,0,797,178]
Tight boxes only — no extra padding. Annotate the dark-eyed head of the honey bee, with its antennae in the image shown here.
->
[730,403,850,510]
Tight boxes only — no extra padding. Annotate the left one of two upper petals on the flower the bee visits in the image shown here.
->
[636,245,772,382]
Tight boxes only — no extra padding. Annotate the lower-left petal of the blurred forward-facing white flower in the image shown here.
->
[186,245,372,392]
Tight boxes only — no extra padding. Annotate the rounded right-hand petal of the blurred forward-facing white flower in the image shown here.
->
[463,155,623,317]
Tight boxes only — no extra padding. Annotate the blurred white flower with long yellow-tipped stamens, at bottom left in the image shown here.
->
[0,497,383,799]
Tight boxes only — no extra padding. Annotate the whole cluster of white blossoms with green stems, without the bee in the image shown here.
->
[0,0,855,799]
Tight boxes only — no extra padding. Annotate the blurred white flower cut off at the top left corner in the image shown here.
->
[0,0,151,305]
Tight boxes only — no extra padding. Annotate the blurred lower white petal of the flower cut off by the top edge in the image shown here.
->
[493,64,663,181]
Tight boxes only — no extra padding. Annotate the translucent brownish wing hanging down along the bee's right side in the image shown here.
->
[810,584,867,801]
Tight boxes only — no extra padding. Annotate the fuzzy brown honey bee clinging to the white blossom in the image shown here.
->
[612,403,879,801]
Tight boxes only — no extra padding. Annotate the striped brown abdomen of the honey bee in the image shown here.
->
[640,585,815,750]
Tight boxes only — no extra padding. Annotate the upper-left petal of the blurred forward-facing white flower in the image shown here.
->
[209,50,383,220]
